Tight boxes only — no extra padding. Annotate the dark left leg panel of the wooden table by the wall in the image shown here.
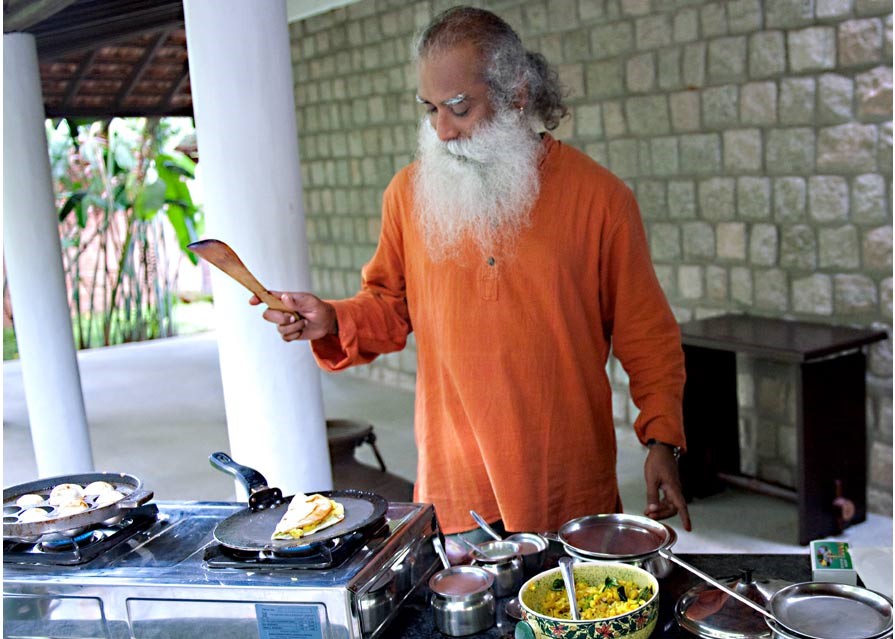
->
[680,345,740,499]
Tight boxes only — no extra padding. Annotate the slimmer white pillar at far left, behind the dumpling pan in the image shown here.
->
[3,33,93,479]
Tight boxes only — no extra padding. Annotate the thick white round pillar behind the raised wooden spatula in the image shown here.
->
[184,0,332,496]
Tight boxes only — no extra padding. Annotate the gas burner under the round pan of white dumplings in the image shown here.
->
[3,504,158,566]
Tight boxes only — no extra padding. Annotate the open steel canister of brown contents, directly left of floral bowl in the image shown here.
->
[429,566,497,637]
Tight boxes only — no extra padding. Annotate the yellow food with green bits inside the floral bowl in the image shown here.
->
[529,577,653,620]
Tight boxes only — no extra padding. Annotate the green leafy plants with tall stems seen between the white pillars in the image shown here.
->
[47,118,202,348]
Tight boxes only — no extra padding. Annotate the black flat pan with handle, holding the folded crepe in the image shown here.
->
[209,452,388,554]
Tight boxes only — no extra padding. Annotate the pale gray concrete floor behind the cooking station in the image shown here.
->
[3,333,893,595]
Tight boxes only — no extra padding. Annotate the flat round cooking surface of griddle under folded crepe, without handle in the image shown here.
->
[214,490,388,553]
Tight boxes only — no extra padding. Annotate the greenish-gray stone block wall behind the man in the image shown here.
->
[291,0,892,515]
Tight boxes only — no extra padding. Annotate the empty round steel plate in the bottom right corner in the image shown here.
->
[769,581,892,639]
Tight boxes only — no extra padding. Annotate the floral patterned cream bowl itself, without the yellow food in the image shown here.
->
[515,561,659,639]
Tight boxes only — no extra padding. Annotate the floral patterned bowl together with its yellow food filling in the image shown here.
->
[515,561,659,639]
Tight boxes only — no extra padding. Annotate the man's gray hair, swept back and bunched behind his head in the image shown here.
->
[414,7,569,131]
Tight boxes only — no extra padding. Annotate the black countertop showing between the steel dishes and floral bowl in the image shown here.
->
[386,554,811,639]
